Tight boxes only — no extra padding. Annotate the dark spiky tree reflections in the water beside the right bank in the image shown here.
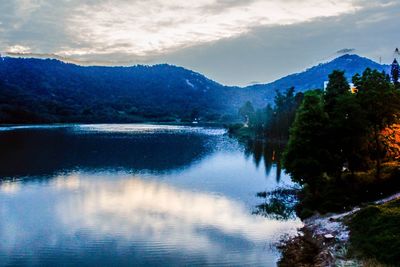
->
[245,140,284,181]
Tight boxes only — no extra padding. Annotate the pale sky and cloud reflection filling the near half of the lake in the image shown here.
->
[0,173,298,266]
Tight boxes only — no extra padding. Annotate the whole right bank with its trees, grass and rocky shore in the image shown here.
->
[230,63,400,266]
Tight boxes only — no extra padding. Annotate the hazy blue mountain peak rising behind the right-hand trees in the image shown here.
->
[248,55,390,95]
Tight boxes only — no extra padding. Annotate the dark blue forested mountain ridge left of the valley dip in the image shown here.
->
[0,58,241,122]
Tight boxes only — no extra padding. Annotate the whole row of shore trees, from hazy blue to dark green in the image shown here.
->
[229,68,400,218]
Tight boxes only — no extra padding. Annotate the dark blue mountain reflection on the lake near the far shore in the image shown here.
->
[0,128,215,178]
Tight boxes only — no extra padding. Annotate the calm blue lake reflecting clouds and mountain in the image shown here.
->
[0,124,301,266]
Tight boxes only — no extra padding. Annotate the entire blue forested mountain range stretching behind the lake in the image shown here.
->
[0,55,389,123]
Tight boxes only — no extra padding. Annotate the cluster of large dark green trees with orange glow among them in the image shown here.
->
[283,69,400,216]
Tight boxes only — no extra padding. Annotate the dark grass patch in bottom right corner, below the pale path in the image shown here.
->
[349,200,400,265]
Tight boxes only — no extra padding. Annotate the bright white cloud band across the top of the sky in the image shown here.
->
[64,0,360,56]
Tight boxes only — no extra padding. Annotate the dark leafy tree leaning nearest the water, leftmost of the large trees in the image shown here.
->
[283,90,330,196]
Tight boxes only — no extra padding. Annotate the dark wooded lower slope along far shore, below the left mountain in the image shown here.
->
[0,77,225,124]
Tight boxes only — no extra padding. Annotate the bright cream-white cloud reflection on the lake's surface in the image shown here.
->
[54,174,298,241]
